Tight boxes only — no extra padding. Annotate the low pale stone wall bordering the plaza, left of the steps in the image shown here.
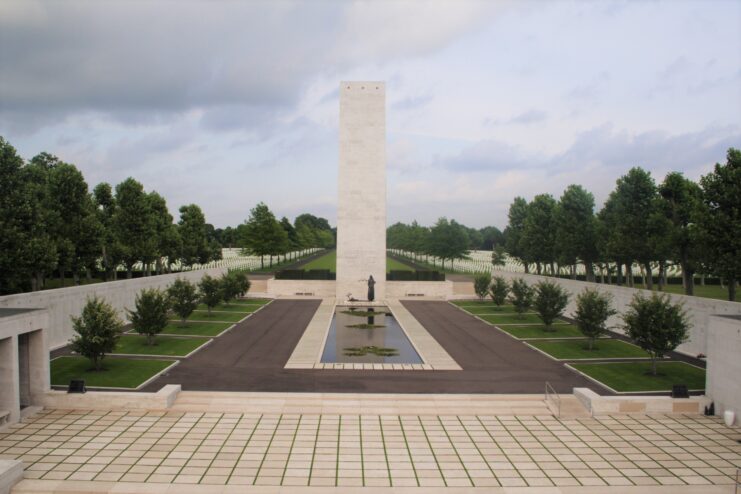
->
[43,384,182,410]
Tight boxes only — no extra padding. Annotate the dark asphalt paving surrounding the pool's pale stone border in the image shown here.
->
[144,300,605,394]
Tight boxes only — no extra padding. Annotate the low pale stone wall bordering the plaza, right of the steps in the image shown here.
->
[574,388,710,415]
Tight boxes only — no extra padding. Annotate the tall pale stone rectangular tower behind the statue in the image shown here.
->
[336,82,386,300]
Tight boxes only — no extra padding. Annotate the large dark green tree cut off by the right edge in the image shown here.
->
[697,148,741,301]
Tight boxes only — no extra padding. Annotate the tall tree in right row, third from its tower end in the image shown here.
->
[554,185,598,281]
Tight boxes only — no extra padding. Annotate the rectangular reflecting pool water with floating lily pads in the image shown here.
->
[322,306,422,364]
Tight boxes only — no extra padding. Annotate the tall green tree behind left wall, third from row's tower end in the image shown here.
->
[113,177,157,278]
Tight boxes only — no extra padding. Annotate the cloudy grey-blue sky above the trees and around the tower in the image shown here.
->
[0,0,741,227]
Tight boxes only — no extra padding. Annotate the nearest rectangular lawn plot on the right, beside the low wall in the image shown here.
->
[571,362,705,392]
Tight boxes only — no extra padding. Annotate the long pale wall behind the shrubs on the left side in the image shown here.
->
[0,268,226,349]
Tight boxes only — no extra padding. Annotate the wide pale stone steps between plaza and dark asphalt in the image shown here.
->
[171,391,589,417]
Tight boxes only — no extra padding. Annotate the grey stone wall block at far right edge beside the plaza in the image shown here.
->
[705,316,741,424]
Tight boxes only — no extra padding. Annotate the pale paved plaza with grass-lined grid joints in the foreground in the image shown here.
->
[0,410,741,492]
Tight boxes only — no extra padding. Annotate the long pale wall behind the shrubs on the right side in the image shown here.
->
[492,271,741,357]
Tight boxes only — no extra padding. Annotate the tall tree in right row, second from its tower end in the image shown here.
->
[522,194,556,274]
